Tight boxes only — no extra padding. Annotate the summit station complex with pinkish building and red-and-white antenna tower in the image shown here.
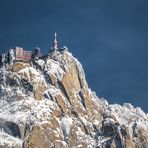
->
[0,33,68,66]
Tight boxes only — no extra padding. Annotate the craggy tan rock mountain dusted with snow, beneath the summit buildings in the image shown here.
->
[0,50,148,148]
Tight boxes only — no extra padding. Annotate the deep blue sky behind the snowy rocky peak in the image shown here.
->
[0,0,148,112]
